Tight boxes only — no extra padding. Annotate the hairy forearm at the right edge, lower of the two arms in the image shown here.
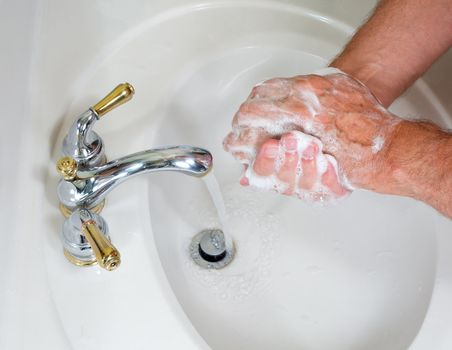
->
[376,121,452,218]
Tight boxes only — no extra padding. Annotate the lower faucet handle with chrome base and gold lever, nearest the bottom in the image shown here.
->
[62,208,121,271]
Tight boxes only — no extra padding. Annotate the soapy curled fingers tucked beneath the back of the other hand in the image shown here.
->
[241,131,349,202]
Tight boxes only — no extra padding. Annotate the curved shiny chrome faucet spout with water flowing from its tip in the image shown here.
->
[57,146,212,209]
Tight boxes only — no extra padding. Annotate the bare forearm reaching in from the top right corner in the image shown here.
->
[331,0,452,106]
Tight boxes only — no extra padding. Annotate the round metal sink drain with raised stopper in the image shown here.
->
[190,229,235,269]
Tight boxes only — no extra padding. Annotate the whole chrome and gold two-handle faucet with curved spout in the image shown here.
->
[57,83,212,271]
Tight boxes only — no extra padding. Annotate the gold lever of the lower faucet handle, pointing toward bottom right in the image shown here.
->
[82,220,121,271]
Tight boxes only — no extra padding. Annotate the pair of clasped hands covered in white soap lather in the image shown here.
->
[224,74,401,199]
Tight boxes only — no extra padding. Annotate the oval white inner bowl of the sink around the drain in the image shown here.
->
[149,19,448,350]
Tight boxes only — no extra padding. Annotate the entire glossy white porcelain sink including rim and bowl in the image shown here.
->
[0,0,452,350]
